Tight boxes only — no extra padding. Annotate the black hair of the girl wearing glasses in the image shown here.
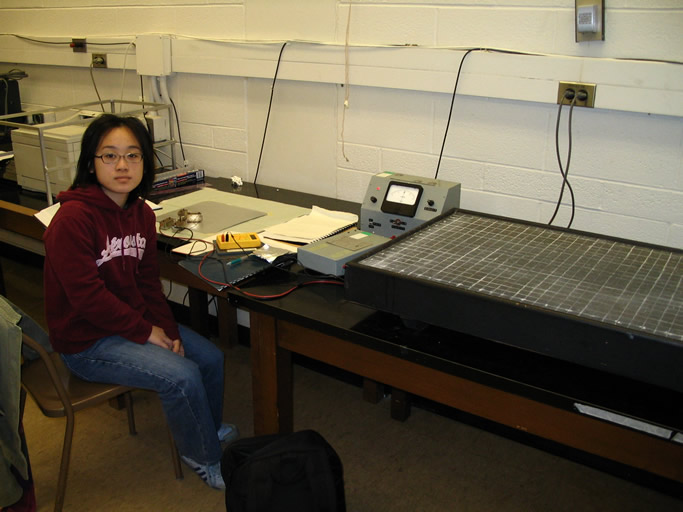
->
[70,114,154,206]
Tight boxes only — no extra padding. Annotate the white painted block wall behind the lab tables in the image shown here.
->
[0,0,683,248]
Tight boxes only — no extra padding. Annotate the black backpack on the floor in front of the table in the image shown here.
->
[221,430,346,512]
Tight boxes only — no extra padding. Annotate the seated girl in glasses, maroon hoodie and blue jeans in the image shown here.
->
[44,114,239,489]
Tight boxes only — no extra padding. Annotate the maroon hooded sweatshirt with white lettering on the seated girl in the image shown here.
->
[43,185,179,354]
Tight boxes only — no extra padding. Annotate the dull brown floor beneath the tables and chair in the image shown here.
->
[5,246,683,512]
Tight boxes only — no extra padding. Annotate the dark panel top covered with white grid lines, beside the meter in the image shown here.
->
[360,212,683,341]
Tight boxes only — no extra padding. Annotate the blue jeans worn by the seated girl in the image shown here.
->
[61,325,223,464]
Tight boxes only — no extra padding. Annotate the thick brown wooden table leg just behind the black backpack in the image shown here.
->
[249,312,294,435]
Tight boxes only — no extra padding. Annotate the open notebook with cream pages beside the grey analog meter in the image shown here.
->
[260,206,358,244]
